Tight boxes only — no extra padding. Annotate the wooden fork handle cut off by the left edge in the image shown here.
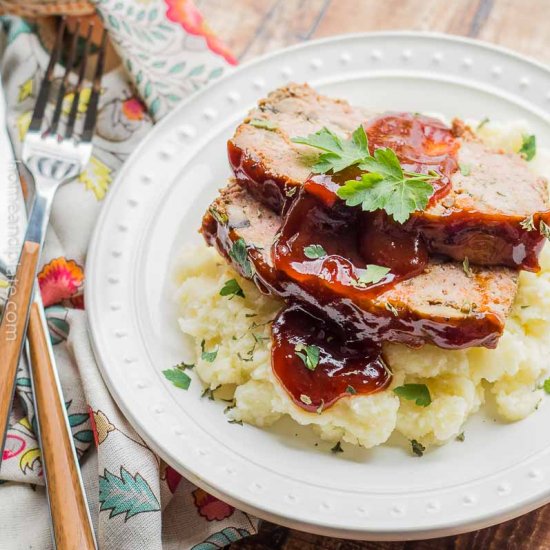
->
[0,241,40,452]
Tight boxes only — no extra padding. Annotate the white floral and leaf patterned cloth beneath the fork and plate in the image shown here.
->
[0,4,257,550]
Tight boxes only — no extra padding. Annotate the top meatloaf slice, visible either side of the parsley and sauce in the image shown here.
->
[228,84,550,271]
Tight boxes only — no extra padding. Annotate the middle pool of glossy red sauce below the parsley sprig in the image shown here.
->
[271,181,428,303]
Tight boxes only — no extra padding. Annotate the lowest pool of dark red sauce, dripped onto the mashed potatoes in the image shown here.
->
[272,306,391,412]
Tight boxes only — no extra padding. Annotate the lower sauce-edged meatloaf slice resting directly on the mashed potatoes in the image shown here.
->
[202,180,518,349]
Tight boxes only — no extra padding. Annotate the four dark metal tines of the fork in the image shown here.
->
[29,18,107,143]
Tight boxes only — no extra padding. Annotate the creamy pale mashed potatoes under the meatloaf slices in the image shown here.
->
[177,124,550,448]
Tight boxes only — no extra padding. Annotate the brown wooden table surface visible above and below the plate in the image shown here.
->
[196,0,550,550]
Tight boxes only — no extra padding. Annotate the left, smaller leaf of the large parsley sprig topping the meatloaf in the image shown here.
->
[292,126,370,174]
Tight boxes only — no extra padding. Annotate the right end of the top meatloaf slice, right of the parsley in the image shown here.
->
[412,138,550,271]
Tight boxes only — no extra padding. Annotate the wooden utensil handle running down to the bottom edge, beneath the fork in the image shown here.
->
[28,302,96,550]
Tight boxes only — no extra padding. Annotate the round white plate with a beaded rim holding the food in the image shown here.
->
[86,33,550,539]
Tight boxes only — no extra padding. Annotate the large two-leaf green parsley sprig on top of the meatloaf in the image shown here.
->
[292,126,441,223]
